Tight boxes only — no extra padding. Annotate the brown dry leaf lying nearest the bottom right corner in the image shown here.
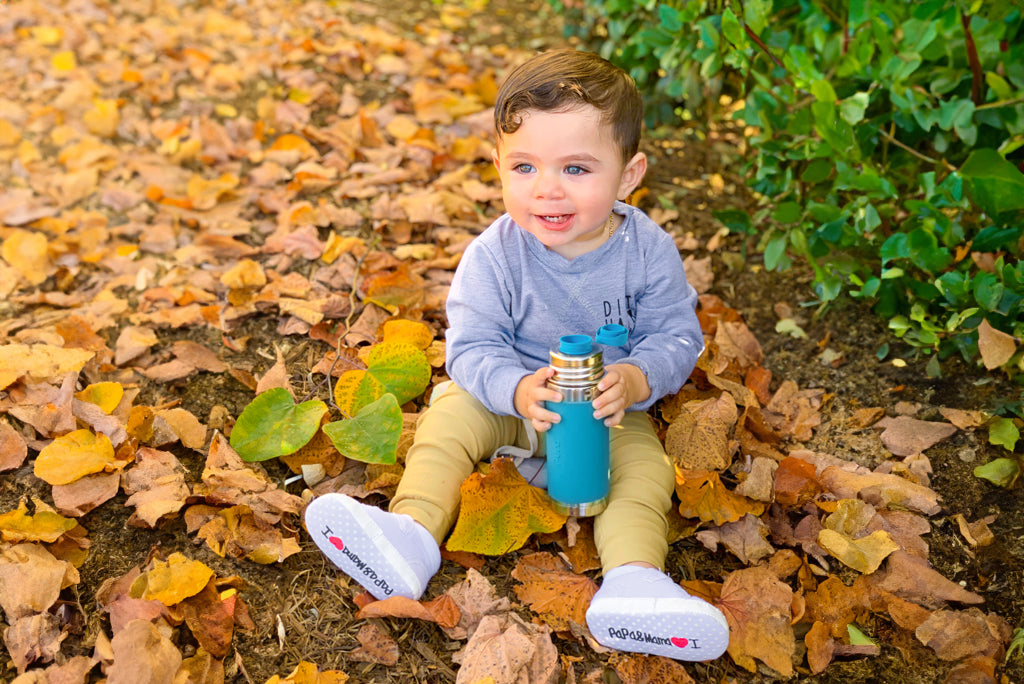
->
[914,608,1011,660]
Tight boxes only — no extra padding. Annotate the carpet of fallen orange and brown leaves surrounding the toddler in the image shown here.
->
[0,0,1012,684]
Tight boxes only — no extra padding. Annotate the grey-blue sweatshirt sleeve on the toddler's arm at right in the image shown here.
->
[620,229,705,411]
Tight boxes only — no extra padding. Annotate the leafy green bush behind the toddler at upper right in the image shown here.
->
[549,0,1024,378]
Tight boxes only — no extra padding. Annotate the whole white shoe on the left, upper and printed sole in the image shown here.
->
[305,494,441,600]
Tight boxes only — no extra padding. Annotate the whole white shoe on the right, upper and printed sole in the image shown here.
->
[587,568,729,661]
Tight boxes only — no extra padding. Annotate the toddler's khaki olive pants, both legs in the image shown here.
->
[390,384,675,572]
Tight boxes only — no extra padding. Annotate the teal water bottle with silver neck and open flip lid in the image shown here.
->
[546,326,629,517]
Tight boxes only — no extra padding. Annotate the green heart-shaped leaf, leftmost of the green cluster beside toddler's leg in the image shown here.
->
[230,387,327,462]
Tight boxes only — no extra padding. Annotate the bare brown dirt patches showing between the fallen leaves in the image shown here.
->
[0,1,1024,684]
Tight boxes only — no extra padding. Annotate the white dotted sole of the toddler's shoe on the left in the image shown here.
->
[305,494,425,600]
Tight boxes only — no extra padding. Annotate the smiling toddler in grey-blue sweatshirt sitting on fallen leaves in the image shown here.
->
[305,50,729,660]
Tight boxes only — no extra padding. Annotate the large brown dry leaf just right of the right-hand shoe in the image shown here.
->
[717,566,797,677]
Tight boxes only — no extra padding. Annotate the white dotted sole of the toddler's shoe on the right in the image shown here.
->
[587,598,729,661]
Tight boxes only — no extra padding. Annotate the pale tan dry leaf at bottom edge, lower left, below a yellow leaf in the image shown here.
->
[106,619,181,684]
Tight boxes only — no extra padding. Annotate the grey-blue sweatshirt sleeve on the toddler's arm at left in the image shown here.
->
[445,235,530,416]
